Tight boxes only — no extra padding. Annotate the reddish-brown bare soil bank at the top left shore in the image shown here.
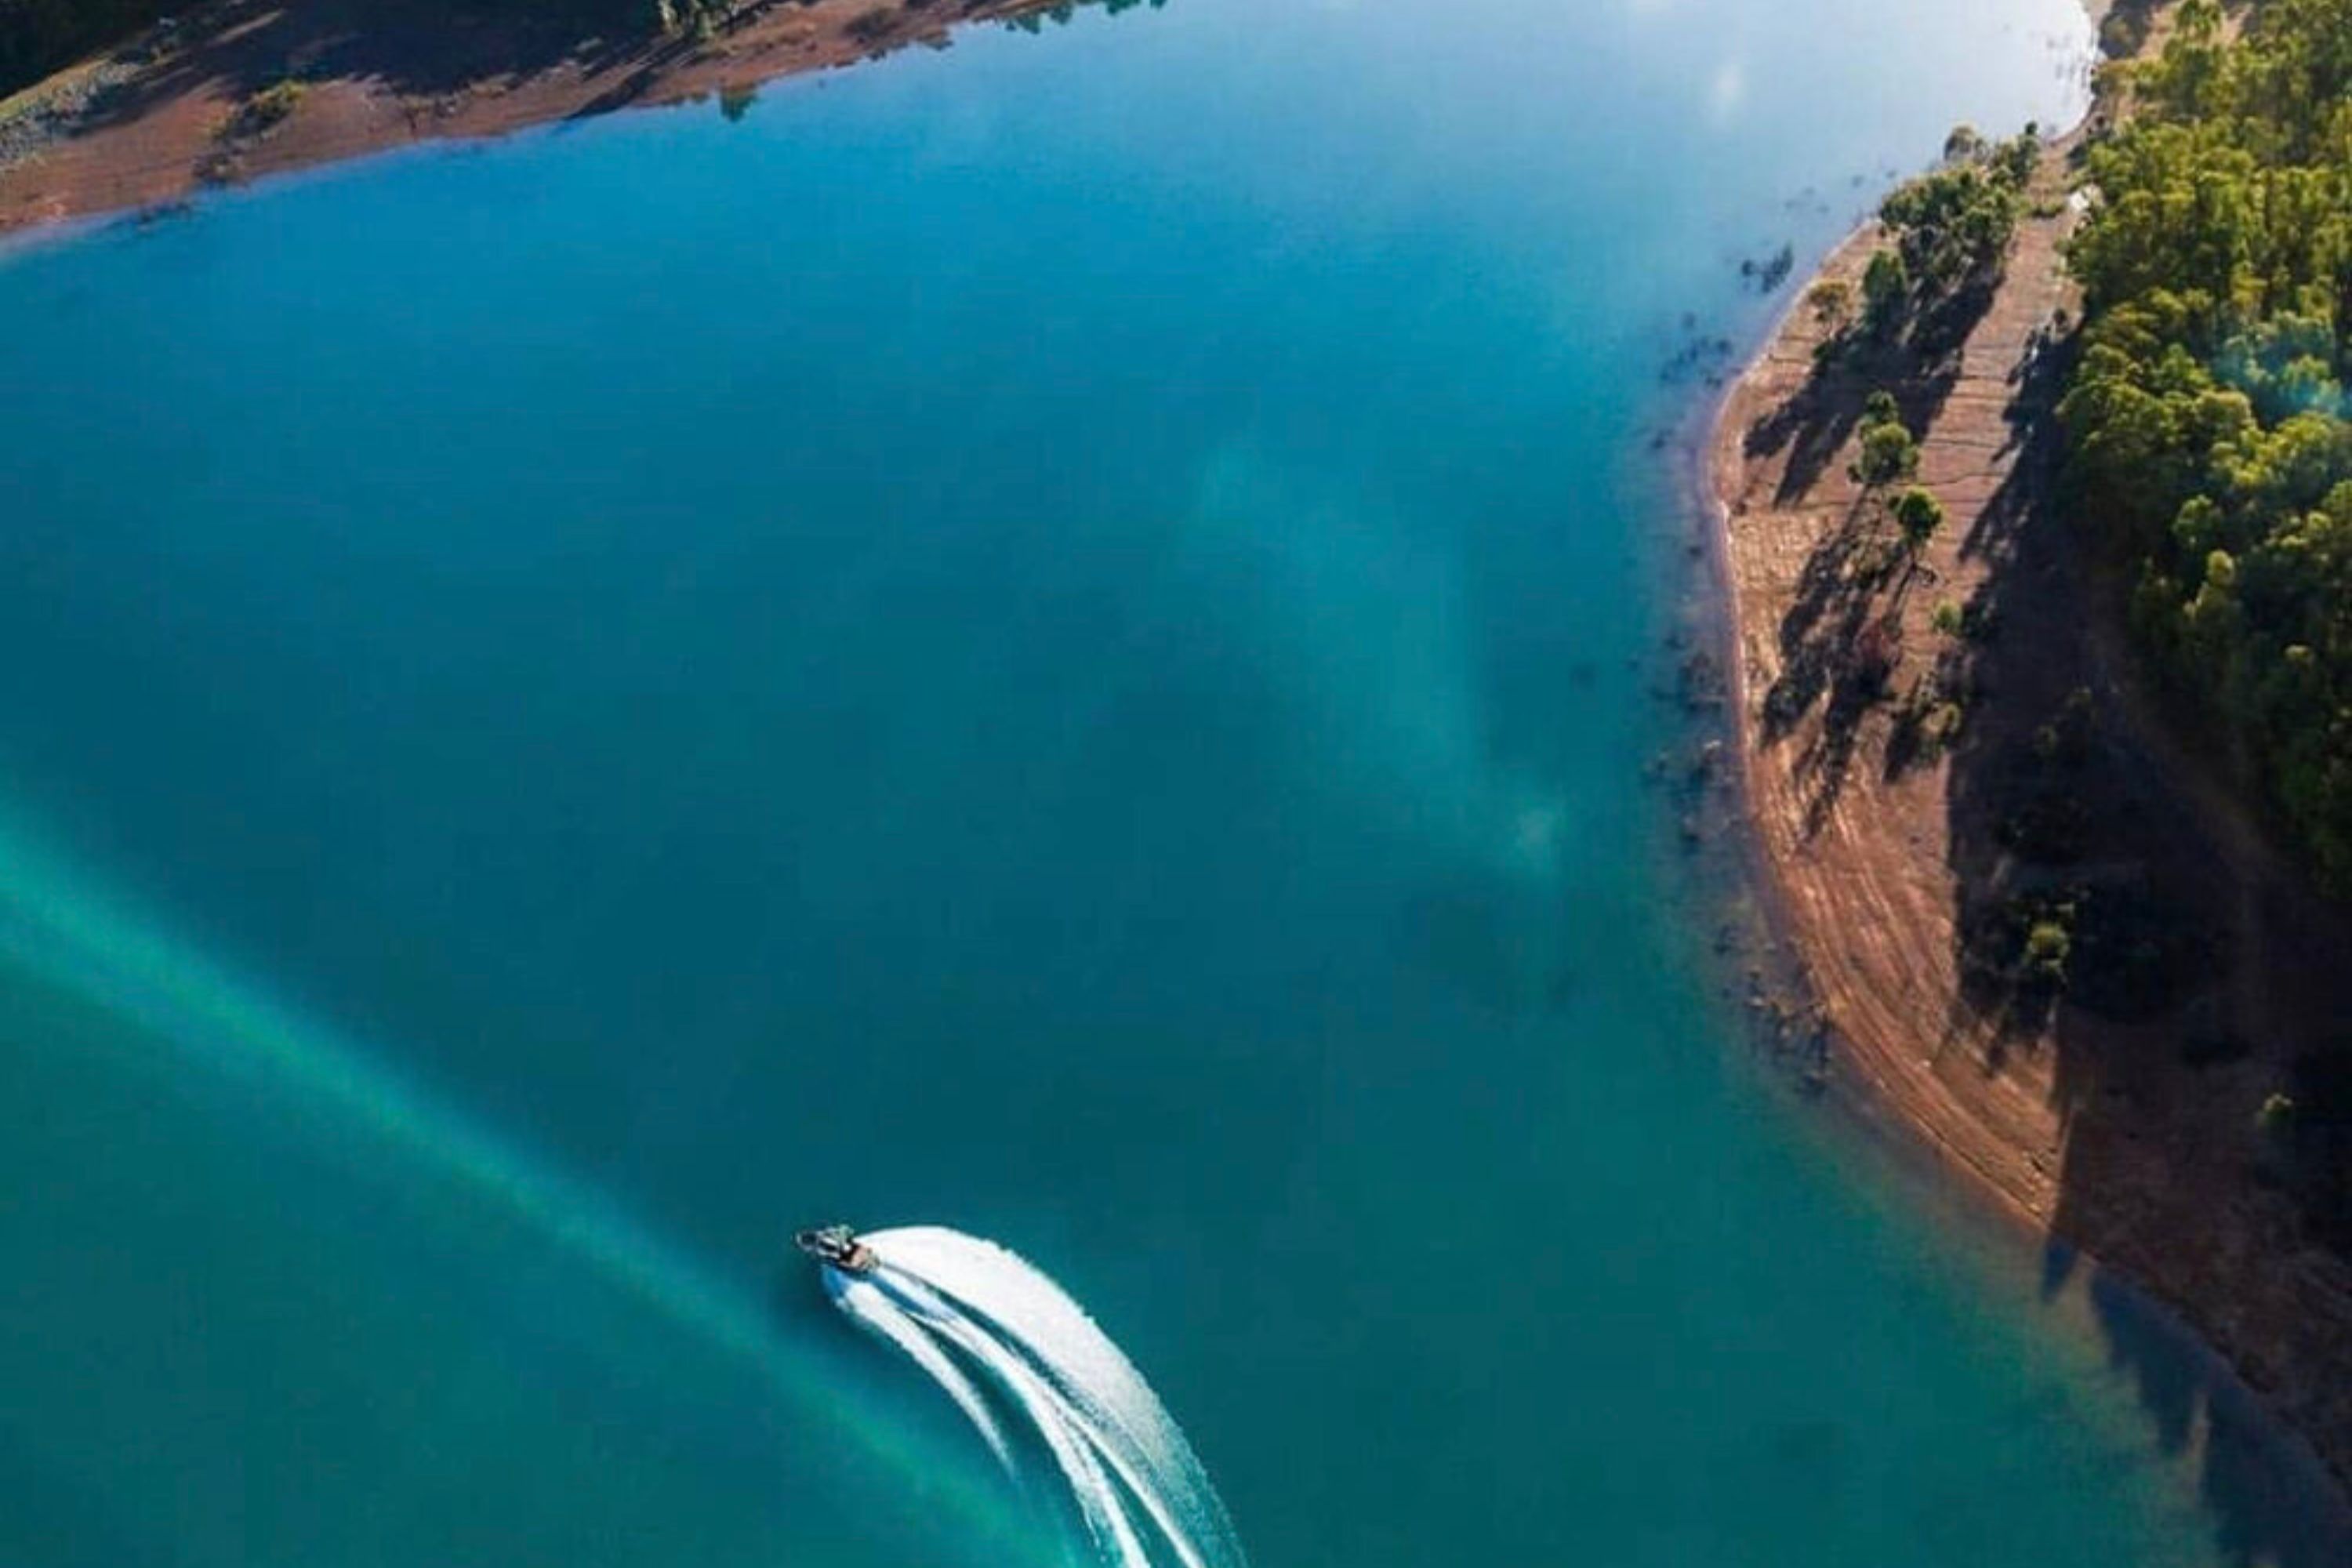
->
[0,0,1087,233]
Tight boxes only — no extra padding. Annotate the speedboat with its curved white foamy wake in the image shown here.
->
[823,1227,1244,1568]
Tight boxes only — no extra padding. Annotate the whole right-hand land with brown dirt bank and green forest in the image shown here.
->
[1710,0,2352,1504]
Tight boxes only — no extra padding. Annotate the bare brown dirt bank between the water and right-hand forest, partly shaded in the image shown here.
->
[1712,15,2352,1547]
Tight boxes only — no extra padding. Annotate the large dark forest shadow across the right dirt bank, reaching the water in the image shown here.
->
[1947,324,2352,1568]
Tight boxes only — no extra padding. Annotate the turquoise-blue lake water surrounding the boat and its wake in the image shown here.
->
[0,0,2328,1568]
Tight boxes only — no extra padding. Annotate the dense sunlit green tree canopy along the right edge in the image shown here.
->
[2060,0,2352,891]
